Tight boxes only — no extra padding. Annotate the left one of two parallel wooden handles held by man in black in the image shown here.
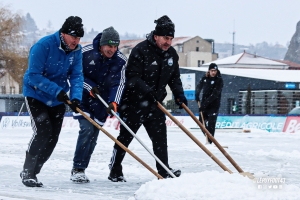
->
[157,102,232,174]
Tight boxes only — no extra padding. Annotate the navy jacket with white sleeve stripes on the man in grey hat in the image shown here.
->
[73,33,127,125]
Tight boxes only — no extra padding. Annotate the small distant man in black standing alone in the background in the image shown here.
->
[196,63,223,144]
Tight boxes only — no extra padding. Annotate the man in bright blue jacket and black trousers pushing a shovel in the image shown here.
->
[20,16,84,187]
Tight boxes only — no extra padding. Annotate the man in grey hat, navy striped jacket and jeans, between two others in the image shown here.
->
[70,27,127,183]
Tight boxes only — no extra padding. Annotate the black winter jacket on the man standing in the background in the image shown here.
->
[196,70,223,112]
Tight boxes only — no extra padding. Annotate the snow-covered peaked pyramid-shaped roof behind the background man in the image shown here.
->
[203,52,289,69]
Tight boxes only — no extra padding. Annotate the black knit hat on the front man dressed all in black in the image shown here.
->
[154,15,175,37]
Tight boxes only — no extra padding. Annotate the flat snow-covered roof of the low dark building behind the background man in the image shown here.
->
[180,66,300,82]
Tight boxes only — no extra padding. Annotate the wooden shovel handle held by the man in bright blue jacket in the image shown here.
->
[67,100,163,179]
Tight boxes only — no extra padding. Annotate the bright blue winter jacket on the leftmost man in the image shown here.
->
[23,31,83,107]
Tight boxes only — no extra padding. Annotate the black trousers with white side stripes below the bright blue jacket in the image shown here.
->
[25,97,66,163]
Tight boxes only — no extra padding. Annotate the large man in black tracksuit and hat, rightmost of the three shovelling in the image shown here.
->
[108,16,187,182]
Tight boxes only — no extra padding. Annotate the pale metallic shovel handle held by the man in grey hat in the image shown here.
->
[96,94,176,178]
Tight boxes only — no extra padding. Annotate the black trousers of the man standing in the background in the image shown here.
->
[199,111,218,143]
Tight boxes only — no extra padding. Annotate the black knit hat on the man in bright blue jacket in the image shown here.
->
[60,16,84,37]
